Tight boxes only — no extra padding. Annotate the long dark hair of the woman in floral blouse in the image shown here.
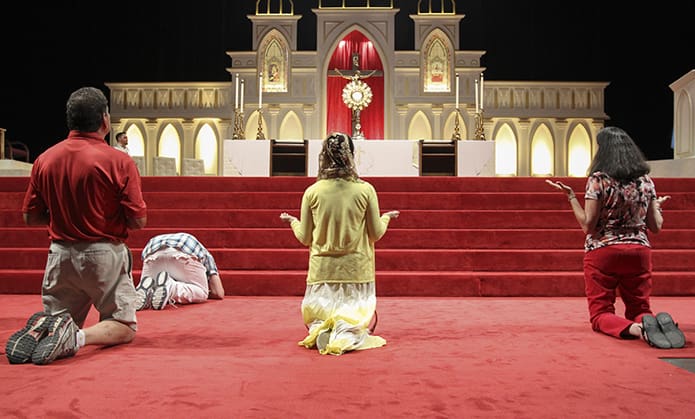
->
[589,127,651,181]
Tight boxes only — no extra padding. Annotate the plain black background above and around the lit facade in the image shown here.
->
[0,0,695,160]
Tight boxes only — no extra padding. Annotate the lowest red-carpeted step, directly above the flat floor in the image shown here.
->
[0,269,695,297]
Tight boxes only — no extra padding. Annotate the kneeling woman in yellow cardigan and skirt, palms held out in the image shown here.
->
[280,133,399,355]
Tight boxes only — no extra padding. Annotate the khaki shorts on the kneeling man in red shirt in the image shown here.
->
[41,241,137,330]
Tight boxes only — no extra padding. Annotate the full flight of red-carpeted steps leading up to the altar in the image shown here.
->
[0,176,695,297]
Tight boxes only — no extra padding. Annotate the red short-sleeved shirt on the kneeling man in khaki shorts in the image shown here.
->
[22,131,147,242]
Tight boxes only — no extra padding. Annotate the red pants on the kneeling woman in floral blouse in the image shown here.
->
[584,244,653,339]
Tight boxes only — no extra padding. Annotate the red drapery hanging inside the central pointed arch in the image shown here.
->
[326,31,384,140]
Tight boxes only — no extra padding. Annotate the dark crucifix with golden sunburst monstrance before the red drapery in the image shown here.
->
[328,52,383,140]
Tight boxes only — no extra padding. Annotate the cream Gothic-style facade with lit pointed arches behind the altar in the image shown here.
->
[107,1,608,176]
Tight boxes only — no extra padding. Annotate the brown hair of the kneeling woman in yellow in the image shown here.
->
[317,132,359,180]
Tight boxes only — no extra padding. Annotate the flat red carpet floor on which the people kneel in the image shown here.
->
[0,295,695,419]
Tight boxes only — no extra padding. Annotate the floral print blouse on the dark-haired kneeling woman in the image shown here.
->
[584,171,656,252]
